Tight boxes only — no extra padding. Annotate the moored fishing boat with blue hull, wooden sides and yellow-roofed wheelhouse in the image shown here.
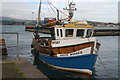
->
[31,2,100,75]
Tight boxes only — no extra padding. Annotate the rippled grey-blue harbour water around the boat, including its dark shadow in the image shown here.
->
[0,25,119,78]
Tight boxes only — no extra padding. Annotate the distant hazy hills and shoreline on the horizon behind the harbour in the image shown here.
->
[0,17,120,27]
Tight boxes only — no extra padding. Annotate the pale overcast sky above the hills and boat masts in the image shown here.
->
[1,0,119,23]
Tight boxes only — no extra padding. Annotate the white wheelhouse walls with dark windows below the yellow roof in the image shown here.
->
[55,27,93,39]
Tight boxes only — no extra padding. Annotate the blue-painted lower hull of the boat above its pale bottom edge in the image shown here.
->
[38,54,97,71]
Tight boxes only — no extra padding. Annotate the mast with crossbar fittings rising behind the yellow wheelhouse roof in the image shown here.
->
[63,1,77,23]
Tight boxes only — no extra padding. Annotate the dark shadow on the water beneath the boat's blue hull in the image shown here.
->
[33,49,94,80]
